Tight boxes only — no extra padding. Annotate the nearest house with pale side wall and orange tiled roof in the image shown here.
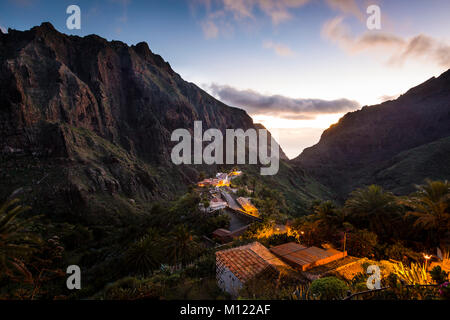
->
[216,242,288,297]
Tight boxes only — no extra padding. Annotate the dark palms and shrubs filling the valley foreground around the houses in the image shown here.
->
[0,178,450,300]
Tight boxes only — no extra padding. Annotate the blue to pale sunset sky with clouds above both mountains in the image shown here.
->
[0,0,450,158]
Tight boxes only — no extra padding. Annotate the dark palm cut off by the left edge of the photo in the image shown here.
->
[0,199,40,274]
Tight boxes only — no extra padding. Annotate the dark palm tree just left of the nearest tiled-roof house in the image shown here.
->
[169,224,200,266]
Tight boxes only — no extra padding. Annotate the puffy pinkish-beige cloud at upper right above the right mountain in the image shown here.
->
[322,17,450,68]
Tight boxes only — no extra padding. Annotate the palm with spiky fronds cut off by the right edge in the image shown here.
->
[400,180,450,242]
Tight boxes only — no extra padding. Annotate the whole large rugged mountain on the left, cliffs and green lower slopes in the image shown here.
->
[0,23,321,223]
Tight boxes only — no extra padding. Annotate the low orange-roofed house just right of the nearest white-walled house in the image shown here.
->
[270,242,347,271]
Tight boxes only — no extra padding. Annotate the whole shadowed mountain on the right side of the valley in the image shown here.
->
[293,71,450,198]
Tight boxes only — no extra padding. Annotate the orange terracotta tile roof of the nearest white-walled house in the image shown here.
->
[216,242,287,283]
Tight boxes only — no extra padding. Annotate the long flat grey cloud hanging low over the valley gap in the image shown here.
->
[209,84,360,120]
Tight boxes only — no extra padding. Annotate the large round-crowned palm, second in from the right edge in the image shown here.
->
[345,185,400,238]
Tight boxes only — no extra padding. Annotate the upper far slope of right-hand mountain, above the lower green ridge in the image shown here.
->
[292,70,450,197]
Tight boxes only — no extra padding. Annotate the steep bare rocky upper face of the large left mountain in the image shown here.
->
[0,23,253,163]
